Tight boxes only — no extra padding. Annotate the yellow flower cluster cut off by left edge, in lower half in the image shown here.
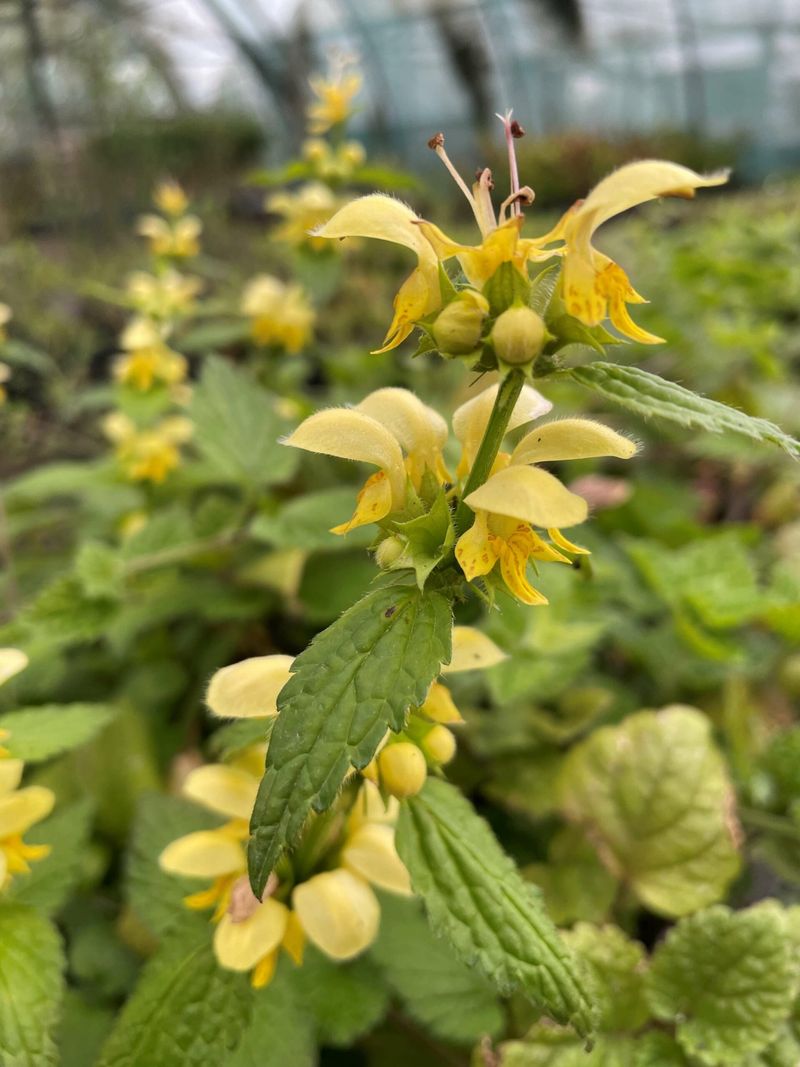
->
[0,649,55,890]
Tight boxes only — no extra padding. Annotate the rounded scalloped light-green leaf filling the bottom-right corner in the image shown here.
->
[647,901,797,1067]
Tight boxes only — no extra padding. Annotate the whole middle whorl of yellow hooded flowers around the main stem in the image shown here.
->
[285,385,637,604]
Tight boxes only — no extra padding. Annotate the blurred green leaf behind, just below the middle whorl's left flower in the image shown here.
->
[250,487,374,552]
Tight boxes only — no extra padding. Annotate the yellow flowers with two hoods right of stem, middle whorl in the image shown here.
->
[455,418,637,604]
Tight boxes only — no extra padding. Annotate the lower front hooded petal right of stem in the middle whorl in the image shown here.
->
[465,466,589,529]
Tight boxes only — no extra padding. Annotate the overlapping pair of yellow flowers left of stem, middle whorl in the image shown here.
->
[284,388,447,534]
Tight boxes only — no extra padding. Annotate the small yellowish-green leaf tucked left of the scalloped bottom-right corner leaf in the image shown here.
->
[562,923,650,1032]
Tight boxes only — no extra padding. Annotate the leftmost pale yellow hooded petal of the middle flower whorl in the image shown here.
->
[284,408,405,505]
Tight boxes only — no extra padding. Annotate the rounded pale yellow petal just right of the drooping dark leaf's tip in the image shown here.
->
[292,867,381,959]
